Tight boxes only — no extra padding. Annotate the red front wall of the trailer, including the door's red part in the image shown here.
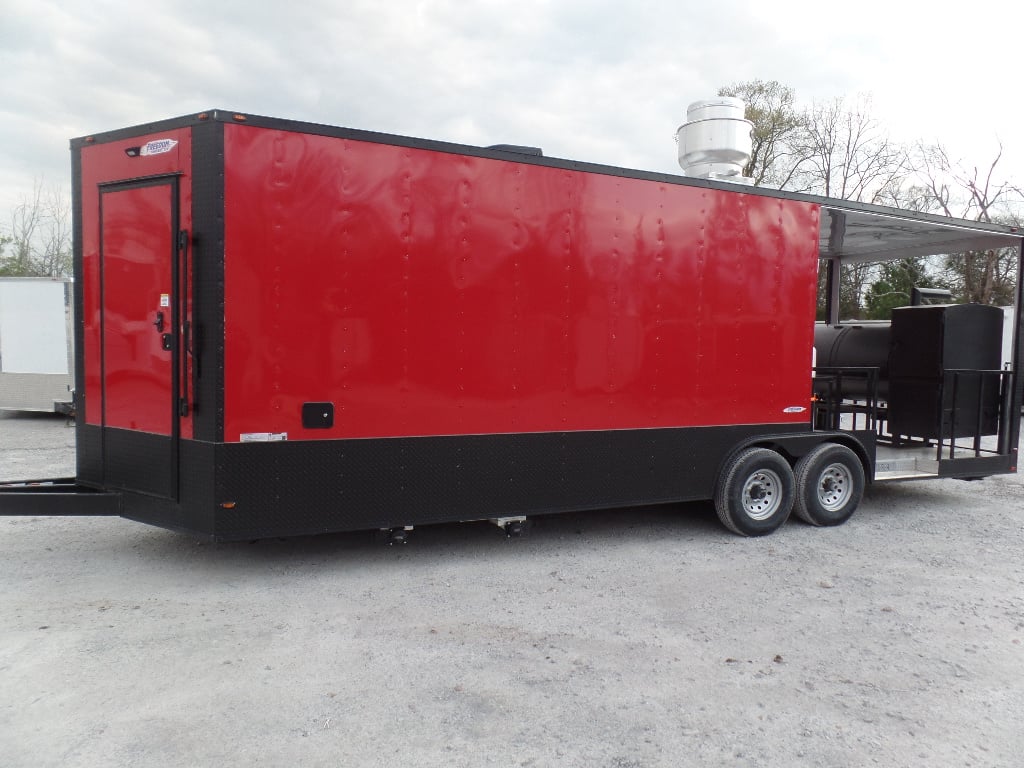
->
[80,128,193,437]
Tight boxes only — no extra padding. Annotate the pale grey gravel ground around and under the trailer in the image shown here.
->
[0,415,1024,768]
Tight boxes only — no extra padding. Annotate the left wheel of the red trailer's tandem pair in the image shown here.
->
[715,447,795,536]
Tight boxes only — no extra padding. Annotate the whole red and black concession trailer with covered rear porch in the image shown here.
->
[0,111,1021,540]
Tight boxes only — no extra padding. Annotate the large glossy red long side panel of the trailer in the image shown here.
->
[224,125,818,441]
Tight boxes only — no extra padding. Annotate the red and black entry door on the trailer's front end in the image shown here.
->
[99,176,180,499]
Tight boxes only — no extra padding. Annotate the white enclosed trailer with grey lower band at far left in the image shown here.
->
[0,278,75,412]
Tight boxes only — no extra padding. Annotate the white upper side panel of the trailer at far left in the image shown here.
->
[0,280,69,374]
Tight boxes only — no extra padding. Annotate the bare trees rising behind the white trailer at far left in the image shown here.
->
[0,179,72,278]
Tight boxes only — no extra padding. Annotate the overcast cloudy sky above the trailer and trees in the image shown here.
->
[0,0,1024,219]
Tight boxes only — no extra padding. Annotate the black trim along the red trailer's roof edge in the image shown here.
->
[71,109,1020,238]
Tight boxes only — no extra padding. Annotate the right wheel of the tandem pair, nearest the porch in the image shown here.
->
[793,442,864,525]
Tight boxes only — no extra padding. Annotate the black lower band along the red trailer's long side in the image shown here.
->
[90,425,833,540]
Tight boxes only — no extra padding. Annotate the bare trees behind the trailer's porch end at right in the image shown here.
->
[719,80,1024,318]
